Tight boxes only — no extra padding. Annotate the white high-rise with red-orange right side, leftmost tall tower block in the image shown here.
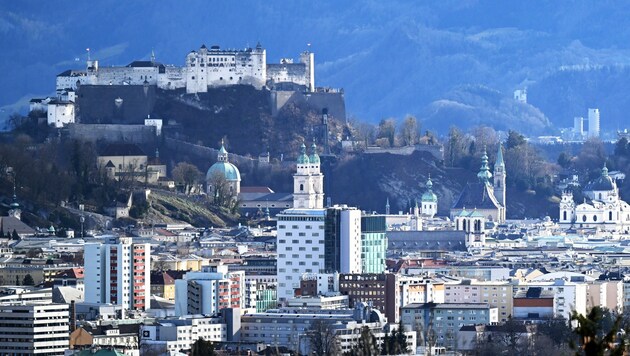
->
[85,237,151,310]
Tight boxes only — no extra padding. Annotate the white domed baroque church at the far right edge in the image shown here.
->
[559,165,630,233]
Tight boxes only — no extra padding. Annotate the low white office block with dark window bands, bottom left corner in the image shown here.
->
[0,302,70,355]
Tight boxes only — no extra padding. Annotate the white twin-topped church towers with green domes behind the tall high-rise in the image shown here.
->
[293,143,324,209]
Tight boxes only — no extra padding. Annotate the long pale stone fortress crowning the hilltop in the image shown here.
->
[56,44,315,94]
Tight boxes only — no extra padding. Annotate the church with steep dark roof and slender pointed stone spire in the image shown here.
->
[450,145,506,223]
